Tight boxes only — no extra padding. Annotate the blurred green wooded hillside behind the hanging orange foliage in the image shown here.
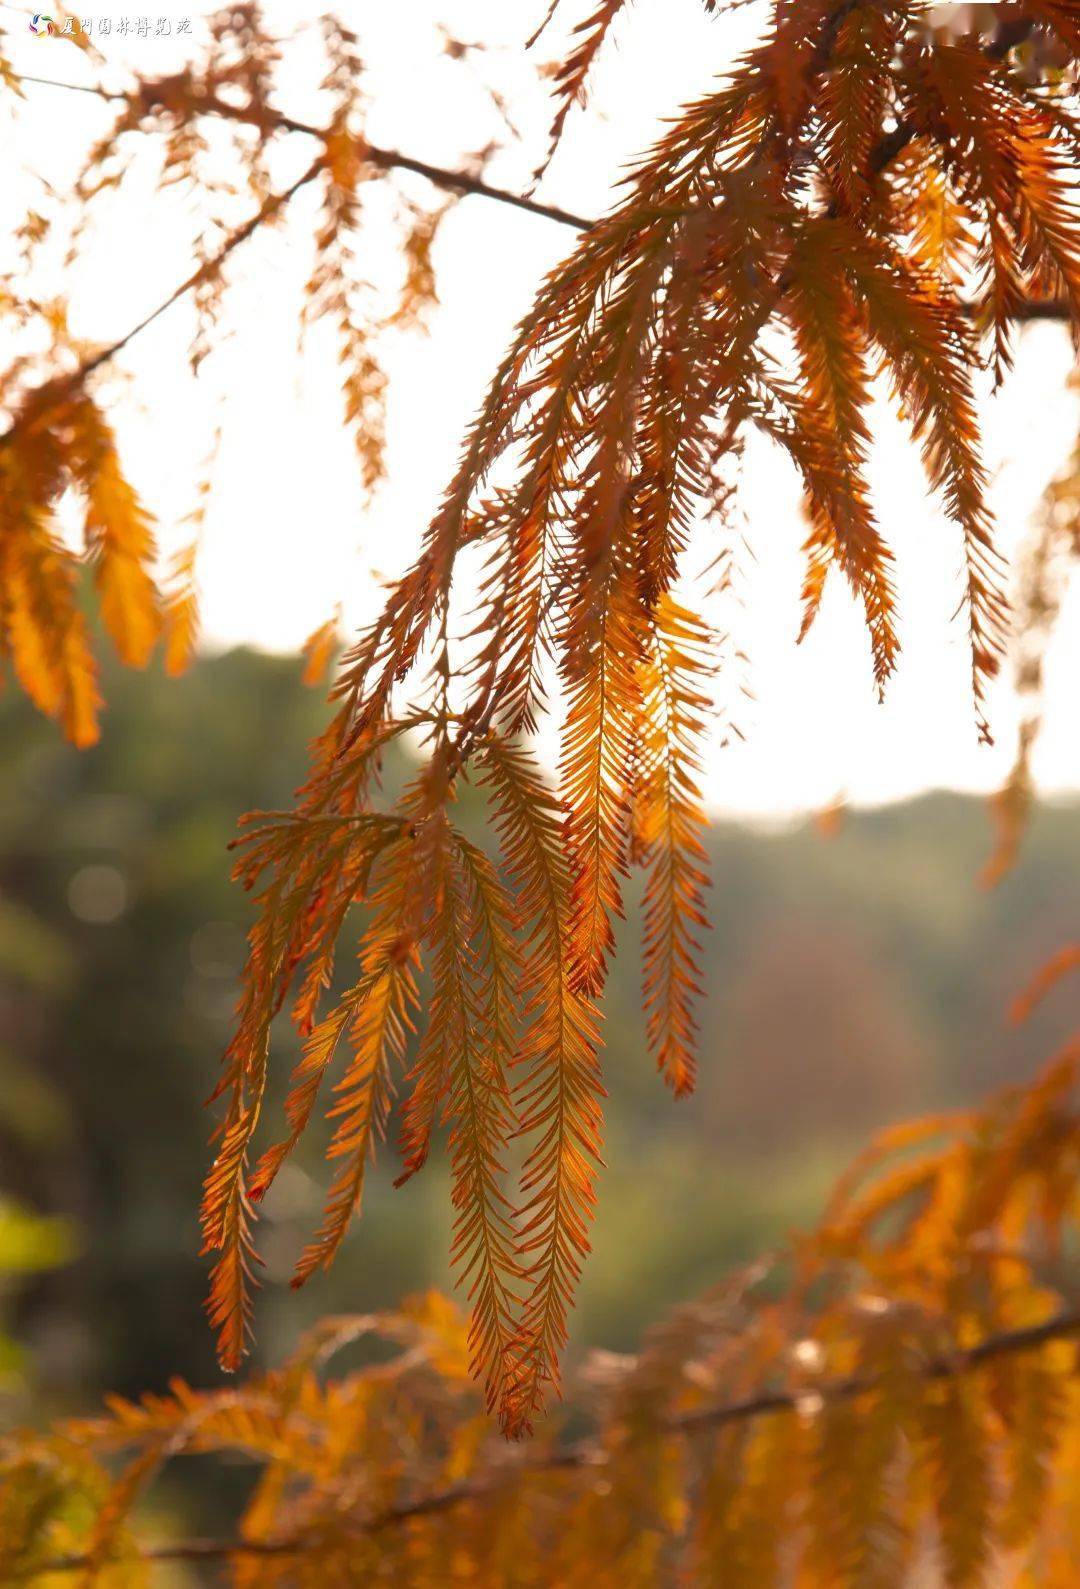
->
[0,651,1080,1417]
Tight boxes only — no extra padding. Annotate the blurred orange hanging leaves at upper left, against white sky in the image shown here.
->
[0,5,470,745]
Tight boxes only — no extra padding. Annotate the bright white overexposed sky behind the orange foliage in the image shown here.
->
[0,0,1080,817]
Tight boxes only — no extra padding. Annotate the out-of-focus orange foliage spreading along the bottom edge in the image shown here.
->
[0,997,1080,1589]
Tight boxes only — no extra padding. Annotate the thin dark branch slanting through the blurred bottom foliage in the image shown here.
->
[22,1308,1080,1579]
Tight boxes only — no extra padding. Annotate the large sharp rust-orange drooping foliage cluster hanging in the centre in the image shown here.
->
[193,3,1080,1433]
